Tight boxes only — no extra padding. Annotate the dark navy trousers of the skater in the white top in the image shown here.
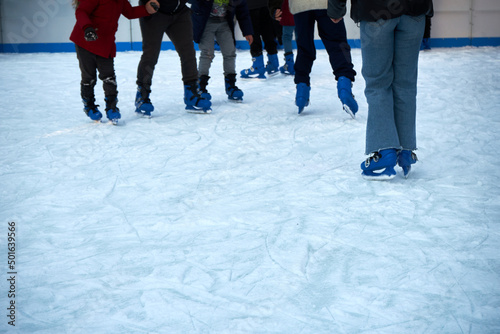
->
[293,9,356,86]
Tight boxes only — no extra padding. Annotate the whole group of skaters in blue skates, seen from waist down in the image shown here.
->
[70,0,432,180]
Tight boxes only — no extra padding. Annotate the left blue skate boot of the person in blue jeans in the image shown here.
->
[361,148,398,180]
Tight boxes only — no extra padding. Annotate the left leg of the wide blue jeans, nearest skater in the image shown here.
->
[360,19,401,154]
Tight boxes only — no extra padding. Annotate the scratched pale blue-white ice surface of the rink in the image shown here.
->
[0,47,500,334]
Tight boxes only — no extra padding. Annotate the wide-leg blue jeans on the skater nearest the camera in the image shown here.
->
[360,15,425,154]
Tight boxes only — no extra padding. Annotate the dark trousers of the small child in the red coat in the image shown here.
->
[76,45,118,102]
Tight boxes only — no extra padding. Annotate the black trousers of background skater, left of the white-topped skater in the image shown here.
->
[250,7,278,57]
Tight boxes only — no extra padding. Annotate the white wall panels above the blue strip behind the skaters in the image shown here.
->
[0,0,500,51]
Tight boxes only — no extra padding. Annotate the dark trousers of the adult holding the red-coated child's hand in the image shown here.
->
[137,7,198,91]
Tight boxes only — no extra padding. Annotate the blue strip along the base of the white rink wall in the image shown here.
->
[0,37,500,53]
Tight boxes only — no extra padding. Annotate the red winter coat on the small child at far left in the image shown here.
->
[69,0,149,58]
